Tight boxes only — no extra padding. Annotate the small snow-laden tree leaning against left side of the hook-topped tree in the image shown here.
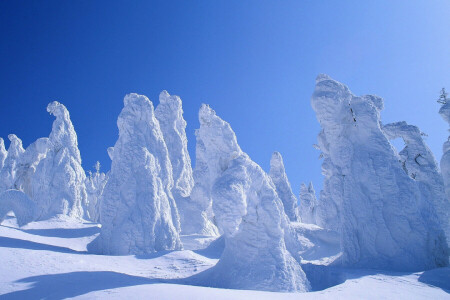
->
[14,138,49,198]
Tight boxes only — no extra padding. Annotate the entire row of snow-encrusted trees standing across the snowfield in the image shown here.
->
[0,75,450,291]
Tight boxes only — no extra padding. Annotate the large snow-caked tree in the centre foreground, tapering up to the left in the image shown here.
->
[193,105,309,291]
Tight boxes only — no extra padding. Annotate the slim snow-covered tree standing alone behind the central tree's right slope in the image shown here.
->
[269,152,300,222]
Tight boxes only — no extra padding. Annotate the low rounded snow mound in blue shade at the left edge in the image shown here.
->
[0,190,36,226]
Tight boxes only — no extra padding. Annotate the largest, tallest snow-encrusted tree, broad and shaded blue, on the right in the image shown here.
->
[311,75,448,270]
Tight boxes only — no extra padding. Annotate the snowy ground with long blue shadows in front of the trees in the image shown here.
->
[0,216,450,300]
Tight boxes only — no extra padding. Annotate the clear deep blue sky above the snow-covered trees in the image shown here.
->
[0,0,450,194]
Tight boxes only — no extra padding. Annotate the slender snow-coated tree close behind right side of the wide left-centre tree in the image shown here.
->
[155,91,218,235]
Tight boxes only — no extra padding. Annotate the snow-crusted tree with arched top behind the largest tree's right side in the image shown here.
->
[382,122,450,242]
